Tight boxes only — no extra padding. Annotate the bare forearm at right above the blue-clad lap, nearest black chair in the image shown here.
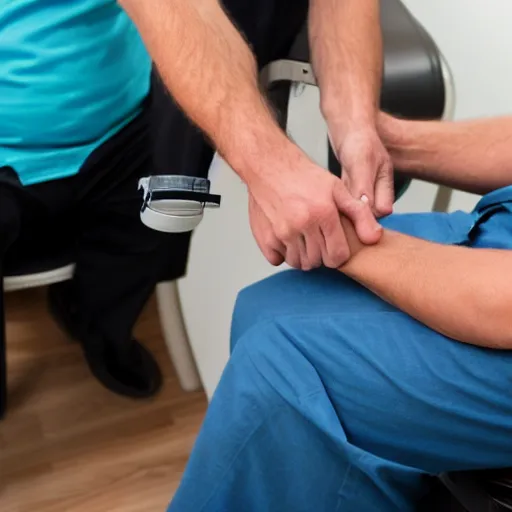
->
[378,115,512,194]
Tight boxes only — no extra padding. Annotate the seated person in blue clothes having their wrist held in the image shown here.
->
[170,114,512,512]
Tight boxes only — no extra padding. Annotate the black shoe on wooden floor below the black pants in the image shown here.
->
[48,282,163,398]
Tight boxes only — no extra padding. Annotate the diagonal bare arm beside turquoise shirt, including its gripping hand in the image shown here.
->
[118,0,380,270]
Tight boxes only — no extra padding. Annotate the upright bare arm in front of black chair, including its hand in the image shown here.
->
[309,0,393,215]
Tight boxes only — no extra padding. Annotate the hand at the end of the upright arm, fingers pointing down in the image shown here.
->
[331,127,394,217]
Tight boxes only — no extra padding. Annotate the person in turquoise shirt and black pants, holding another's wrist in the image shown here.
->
[0,0,384,396]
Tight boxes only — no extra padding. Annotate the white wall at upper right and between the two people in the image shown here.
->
[180,0,512,396]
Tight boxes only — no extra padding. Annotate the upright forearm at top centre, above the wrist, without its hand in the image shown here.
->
[309,0,382,131]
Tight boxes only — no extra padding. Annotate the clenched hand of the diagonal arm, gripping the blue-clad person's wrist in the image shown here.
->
[249,161,382,270]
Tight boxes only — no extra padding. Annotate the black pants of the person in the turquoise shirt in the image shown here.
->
[0,89,189,343]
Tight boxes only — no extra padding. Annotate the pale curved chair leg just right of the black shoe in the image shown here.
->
[156,281,201,391]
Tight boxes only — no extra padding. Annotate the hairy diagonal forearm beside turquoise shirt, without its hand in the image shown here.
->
[119,0,301,181]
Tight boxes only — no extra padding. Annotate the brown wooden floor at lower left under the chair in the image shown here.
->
[0,290,206,512]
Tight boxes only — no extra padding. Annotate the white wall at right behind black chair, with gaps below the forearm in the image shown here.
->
[398,0,512,211]
